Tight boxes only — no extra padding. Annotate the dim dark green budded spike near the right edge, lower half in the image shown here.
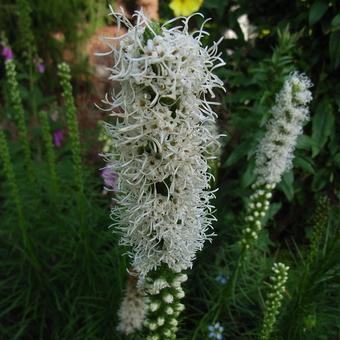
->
[307,196,330,266]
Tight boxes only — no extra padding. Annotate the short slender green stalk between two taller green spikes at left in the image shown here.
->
[39,111,59,200]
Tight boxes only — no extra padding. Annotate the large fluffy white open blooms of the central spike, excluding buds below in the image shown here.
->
[103,12,224,279]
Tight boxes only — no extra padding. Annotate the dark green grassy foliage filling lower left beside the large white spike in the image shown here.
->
[0,55,126,339]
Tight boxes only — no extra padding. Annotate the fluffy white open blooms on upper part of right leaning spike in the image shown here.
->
[255,72,312,184]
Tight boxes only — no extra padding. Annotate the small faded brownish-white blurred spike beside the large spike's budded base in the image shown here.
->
[117,276,147,335]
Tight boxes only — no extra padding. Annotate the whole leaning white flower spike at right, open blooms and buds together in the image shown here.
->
[241,72,312,249]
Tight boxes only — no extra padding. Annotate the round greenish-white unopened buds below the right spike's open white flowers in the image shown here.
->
[241,183,275,249]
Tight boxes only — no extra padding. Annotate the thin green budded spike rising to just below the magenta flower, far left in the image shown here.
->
[5,59,35,184]
